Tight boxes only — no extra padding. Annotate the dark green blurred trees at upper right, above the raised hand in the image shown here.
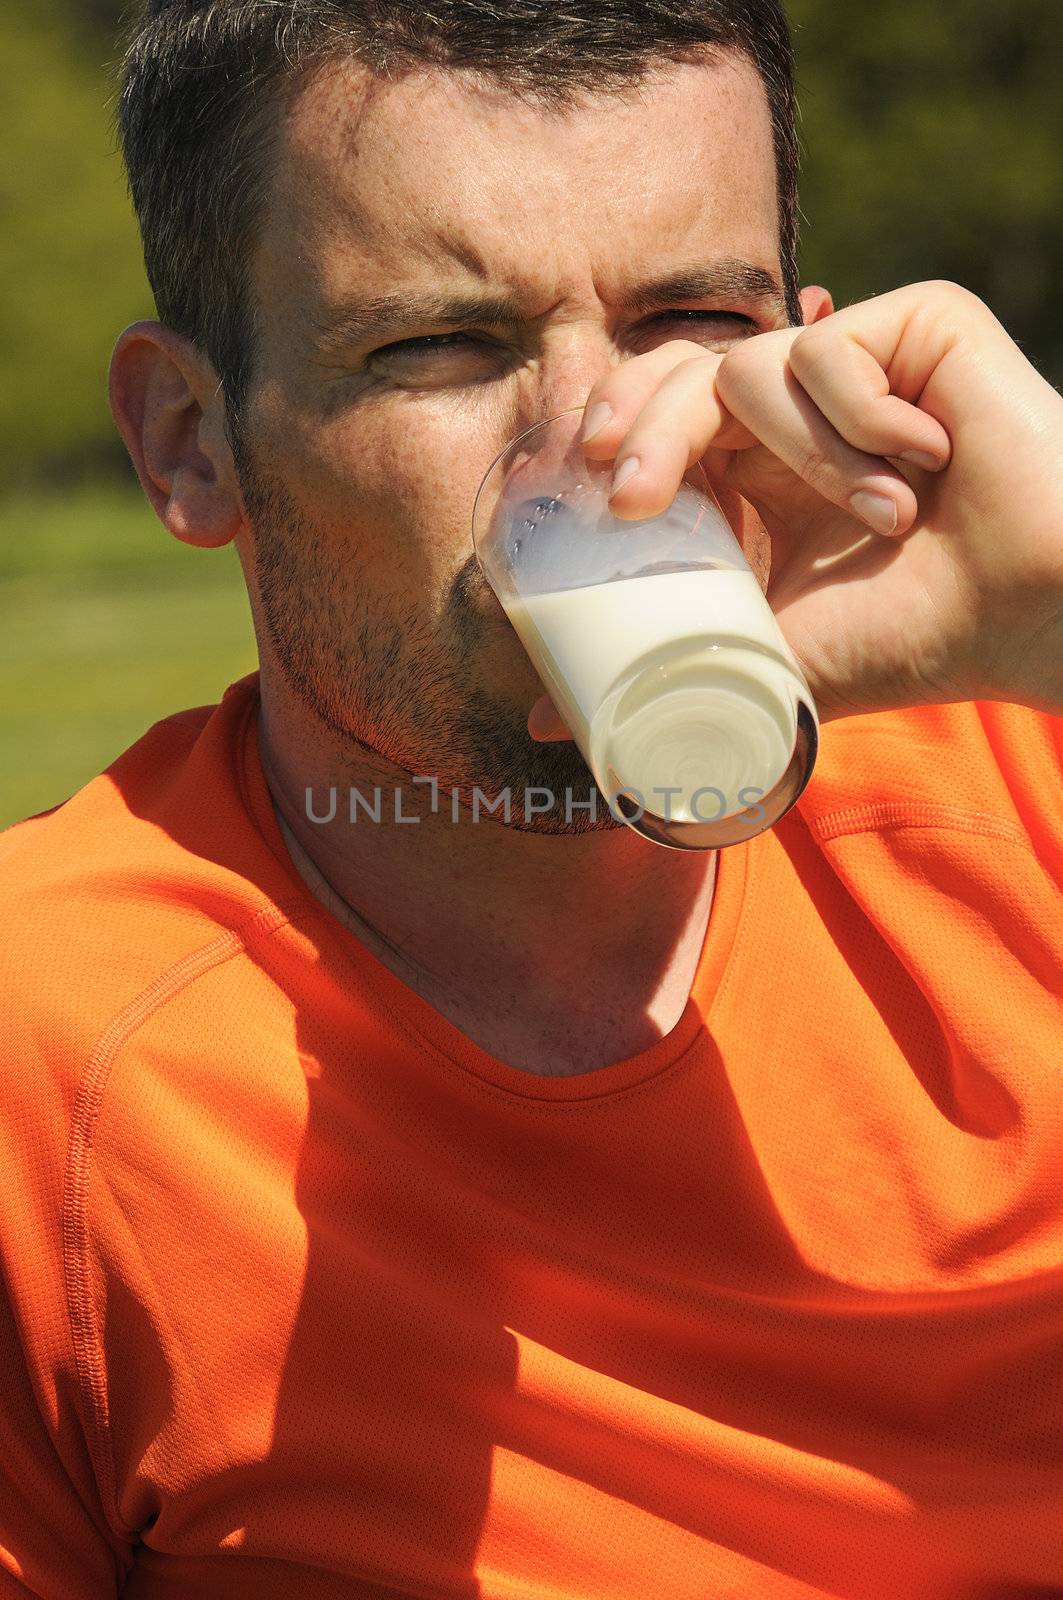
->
[788,0,1063,384]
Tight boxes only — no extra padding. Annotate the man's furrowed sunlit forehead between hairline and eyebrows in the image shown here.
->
[255,51,778,324]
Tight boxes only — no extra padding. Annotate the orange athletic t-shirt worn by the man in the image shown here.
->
[0,674,1063,1600]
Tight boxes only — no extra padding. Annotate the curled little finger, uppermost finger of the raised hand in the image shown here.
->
[789,317,953,472]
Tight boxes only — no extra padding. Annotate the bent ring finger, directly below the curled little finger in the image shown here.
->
[704,330,919,534]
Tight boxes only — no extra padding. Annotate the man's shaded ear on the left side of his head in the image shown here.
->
[107,322,243,547]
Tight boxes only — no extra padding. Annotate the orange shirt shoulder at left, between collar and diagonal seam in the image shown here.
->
[0,675,294,1114]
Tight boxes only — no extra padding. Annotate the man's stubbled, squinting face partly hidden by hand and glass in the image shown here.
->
[239,56,786,832]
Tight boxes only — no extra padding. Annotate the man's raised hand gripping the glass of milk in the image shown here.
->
[528,282,1063,739]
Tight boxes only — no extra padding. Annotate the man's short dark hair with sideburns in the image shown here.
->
[117,0,800,451]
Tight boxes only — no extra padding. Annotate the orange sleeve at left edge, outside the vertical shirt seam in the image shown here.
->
[0,822,134,1600]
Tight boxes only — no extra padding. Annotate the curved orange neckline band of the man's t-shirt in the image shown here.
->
[234,674,746,1104]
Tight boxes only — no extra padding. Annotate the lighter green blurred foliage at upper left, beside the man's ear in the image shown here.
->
[0,0,154,483]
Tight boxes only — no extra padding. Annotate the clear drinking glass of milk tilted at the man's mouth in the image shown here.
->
[472,406,820,850]
